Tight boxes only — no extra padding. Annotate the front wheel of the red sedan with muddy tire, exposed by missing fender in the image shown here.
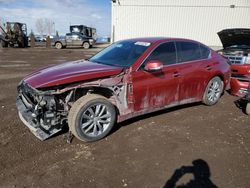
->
[68,94,116,142]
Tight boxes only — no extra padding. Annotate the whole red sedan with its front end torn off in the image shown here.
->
[17,38,230,141]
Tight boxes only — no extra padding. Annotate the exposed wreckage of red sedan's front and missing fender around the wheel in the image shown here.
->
[16,73,127,140]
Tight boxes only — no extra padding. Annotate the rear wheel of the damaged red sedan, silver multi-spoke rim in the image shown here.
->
[202,76,224,106]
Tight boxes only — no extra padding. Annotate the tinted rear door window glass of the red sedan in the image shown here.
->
[176,41,201,62]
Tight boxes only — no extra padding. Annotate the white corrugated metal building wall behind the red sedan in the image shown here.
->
[112,0,250,46]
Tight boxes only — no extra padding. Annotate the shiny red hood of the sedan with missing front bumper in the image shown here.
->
[24,60,123,88]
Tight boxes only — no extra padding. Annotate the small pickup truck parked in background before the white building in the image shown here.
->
[53,33,94,49]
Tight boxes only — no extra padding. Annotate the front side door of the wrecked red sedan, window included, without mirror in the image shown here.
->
[131,42,180,112]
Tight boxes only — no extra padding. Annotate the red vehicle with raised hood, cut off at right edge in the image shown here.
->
[218,29,250,97]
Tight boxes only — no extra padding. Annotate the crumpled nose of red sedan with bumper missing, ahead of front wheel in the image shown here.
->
[16,81,66,140]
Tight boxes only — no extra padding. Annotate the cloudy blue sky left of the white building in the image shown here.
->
[0,0,111,36]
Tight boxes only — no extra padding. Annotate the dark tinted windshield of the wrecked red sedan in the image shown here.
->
[89,41,151,67]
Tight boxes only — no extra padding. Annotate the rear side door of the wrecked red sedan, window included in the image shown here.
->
[176,41,211,103]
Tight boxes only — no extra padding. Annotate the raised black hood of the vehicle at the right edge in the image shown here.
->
[218,29,250,48]
